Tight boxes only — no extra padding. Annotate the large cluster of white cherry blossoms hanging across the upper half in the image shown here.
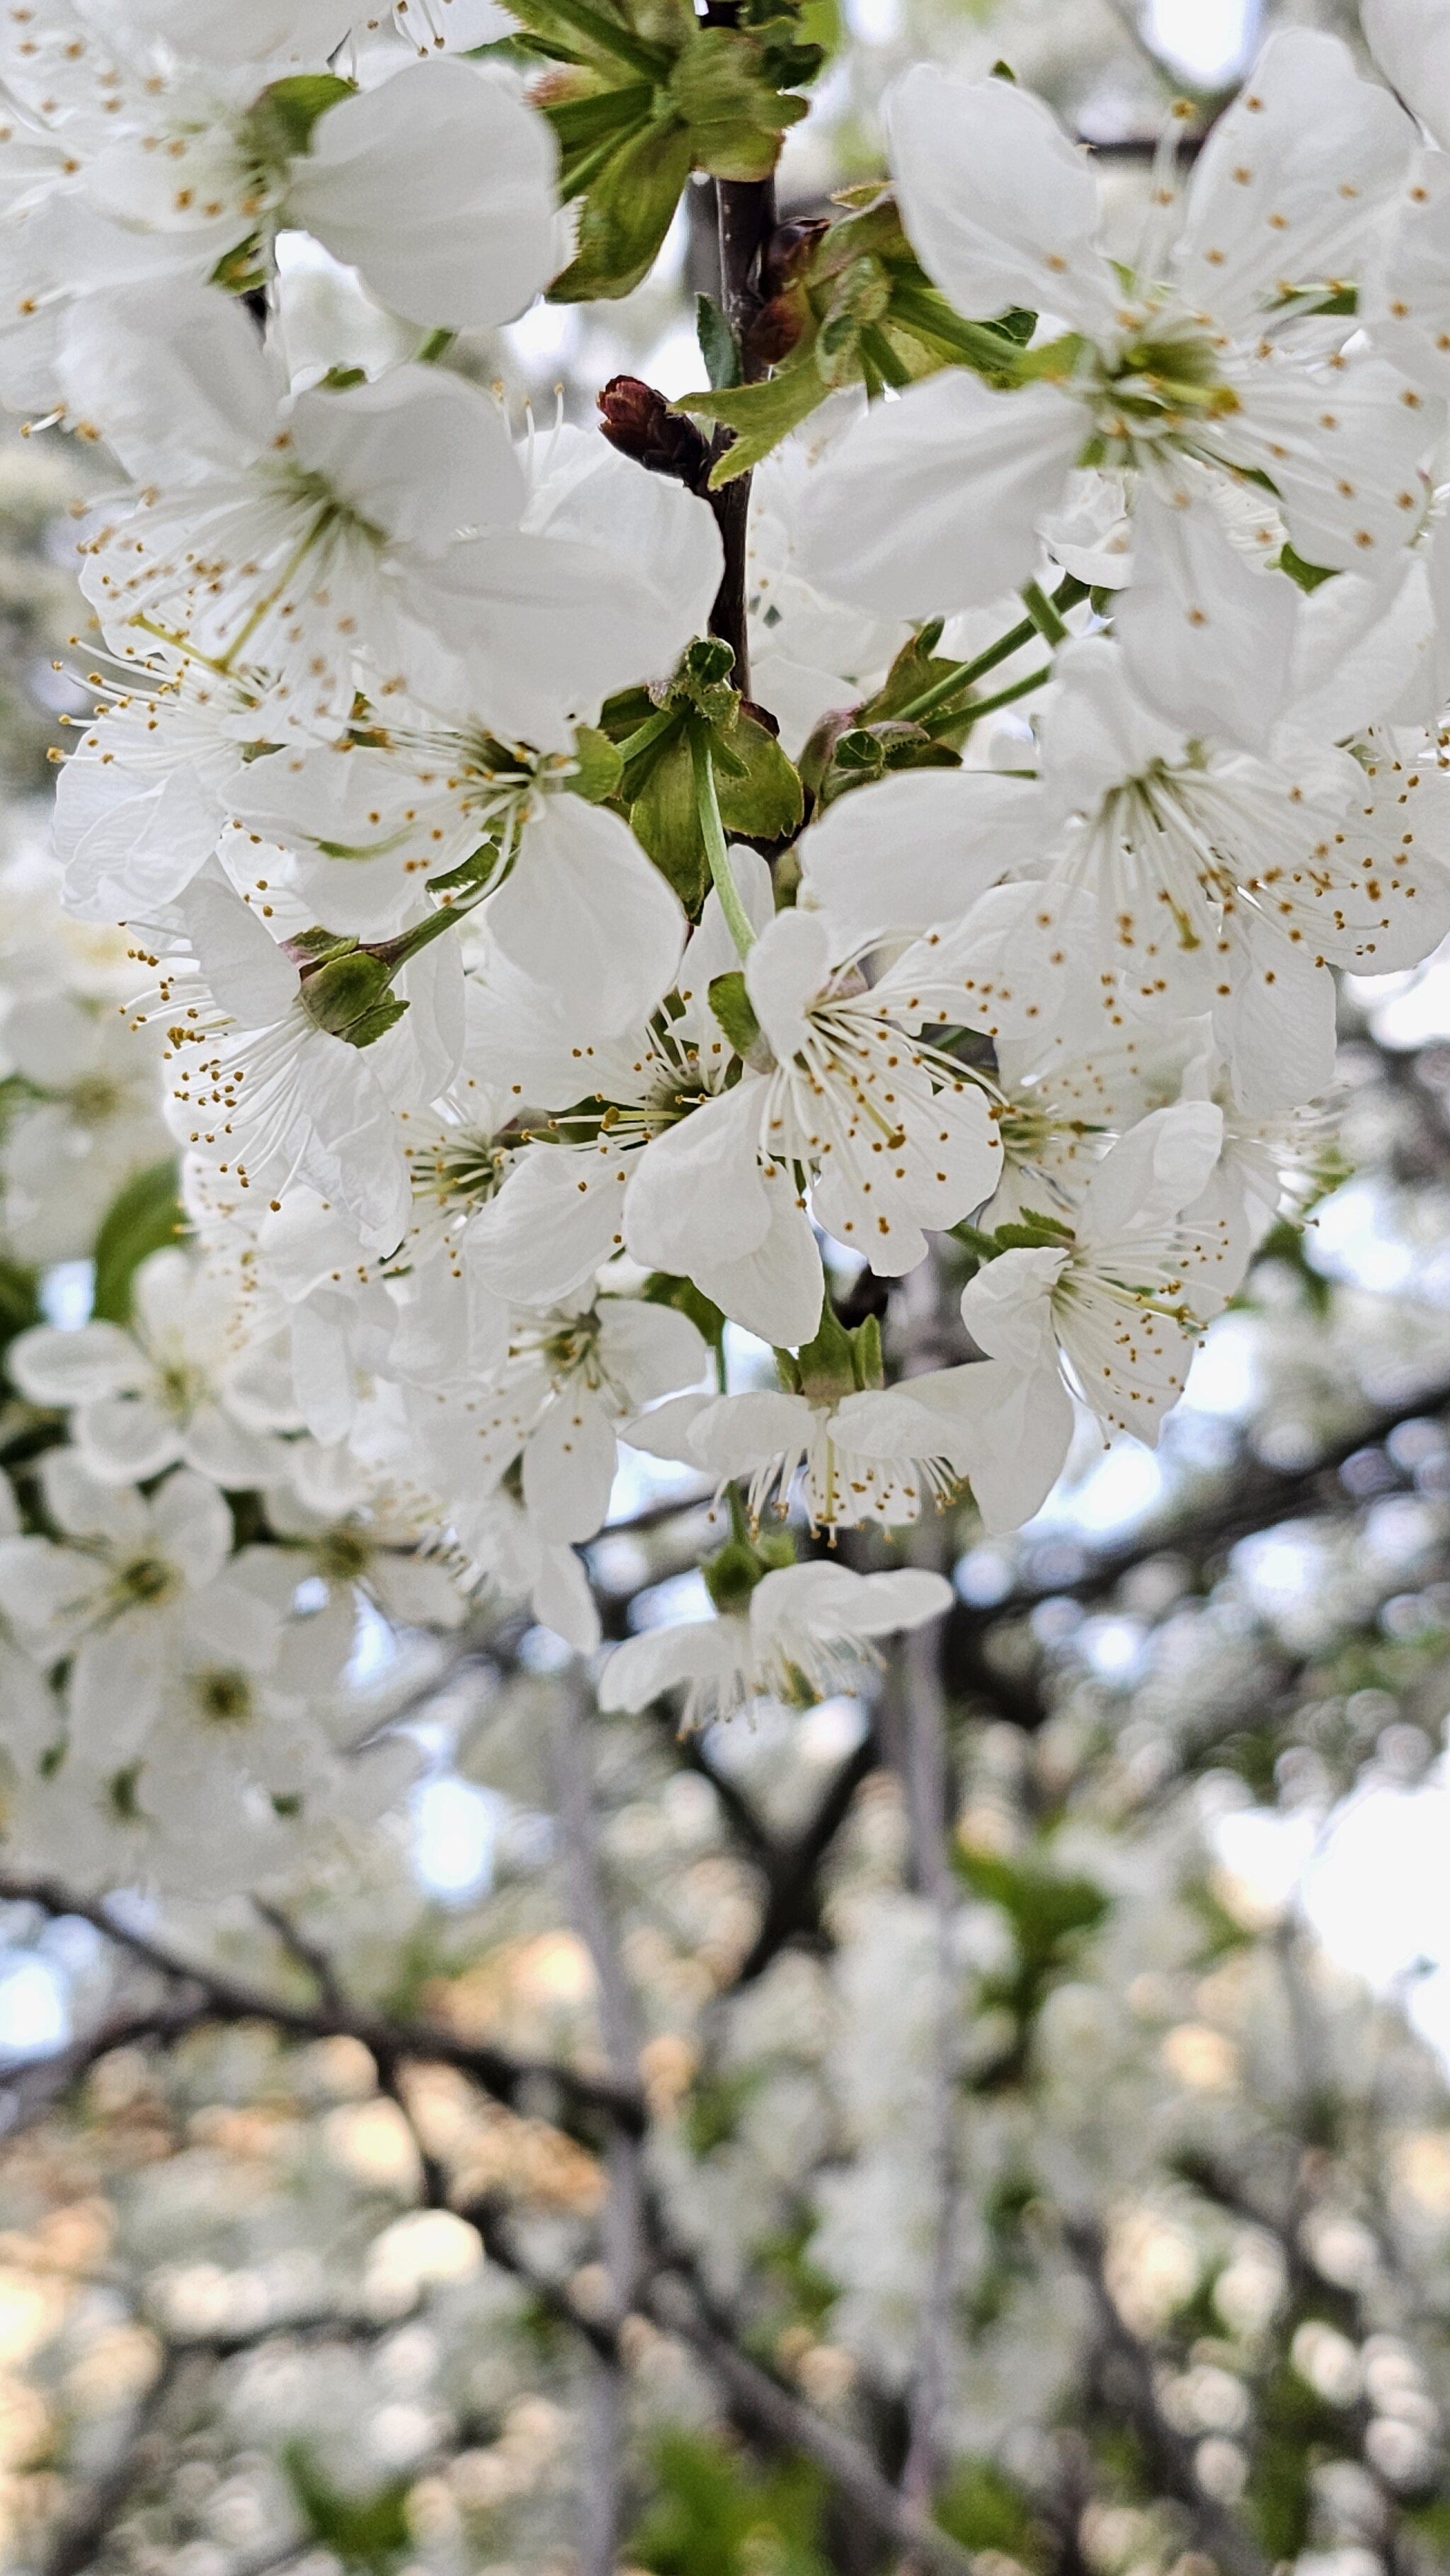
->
[0,0,1450,1865]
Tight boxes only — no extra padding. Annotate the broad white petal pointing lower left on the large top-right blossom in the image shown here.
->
[796,368,1084,618]
